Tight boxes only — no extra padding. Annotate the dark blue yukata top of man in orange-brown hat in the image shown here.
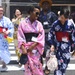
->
[38,10,58,29]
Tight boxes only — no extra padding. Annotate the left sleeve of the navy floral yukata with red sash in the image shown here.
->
[48,24,56,46]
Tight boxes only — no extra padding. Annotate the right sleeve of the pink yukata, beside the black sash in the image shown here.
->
[37,23,45,55]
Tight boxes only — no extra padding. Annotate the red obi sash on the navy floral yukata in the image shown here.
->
[55,31,70,42]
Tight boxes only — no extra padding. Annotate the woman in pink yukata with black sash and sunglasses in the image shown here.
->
[18,6,45,75]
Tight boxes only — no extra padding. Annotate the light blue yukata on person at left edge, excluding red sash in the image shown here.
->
[0,16,14,64]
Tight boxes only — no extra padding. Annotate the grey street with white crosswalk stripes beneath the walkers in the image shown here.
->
[0,42,75,75]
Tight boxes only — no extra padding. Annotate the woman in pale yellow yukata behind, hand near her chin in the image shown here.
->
[12,9,24,66]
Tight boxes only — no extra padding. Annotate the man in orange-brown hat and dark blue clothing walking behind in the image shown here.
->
[38,0,57,74]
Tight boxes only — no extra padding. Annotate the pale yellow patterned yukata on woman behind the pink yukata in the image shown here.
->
[12,17,24,61]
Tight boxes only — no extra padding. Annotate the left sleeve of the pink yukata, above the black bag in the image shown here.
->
[17,23,26,48]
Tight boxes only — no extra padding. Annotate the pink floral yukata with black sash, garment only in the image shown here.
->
[18,17,45,75]
